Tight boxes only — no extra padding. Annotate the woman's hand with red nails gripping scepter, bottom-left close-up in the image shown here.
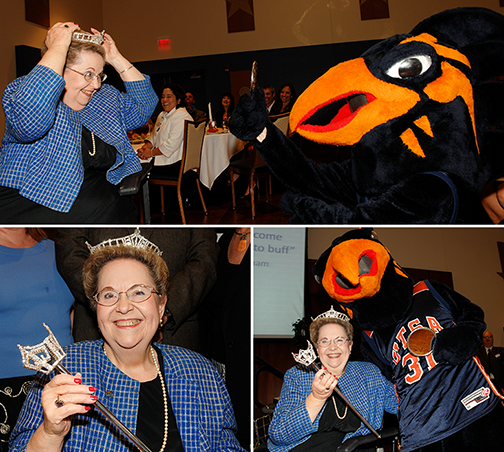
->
[42,374,98,438]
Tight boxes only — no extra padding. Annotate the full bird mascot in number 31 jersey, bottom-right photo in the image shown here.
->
[313,229,504,452]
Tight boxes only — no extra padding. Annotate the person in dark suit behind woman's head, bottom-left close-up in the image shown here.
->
[55,228,218,352]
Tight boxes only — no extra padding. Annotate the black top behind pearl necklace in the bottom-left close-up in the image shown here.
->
[136,348,184,452]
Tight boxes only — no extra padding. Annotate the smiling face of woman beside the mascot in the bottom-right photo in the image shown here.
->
[317,323,352,376]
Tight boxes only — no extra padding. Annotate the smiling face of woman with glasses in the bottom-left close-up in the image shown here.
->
[96,259,166,351]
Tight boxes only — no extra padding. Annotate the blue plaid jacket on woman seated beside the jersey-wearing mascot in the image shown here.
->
[268,362,398,452]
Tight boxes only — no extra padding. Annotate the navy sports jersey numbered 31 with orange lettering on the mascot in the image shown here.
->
[364,281,499,452]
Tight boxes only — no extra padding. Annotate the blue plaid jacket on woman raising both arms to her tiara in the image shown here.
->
[0,65,158,212]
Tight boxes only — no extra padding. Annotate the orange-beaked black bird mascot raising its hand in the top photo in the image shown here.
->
[230,8,504,224]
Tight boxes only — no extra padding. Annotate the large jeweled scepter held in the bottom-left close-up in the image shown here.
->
[18,323,151,452]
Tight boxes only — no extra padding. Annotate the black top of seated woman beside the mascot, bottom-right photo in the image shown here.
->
[292,392,361,452]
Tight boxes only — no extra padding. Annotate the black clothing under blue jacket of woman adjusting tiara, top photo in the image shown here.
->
[0,127,138,224]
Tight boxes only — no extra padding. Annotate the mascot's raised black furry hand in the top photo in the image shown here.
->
[229,87,269,141]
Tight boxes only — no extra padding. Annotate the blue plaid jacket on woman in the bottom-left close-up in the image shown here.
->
[9,340,244,452]
